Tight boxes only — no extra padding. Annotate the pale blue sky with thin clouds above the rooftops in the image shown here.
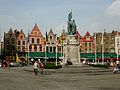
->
[0,0,120,37]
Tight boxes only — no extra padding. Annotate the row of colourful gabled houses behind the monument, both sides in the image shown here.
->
[1,24,120,62]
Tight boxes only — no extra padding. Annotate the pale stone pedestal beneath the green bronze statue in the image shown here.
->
[63,35,80,65]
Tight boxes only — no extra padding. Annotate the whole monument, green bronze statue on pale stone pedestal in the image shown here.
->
[63,12,80,65]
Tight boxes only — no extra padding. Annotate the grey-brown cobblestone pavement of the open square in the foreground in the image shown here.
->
[0,66,120,90]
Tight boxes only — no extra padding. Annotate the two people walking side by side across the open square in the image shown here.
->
[34,60,44,76]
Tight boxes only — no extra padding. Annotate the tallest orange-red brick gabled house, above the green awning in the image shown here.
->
[27,24,45,52]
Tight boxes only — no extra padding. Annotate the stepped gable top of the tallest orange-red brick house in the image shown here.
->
[30,24,43,37]
